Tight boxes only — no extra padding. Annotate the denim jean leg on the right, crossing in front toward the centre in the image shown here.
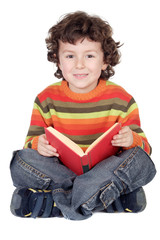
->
[72,147,156,218]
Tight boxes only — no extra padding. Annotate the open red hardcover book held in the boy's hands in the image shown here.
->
[45,123,121,175]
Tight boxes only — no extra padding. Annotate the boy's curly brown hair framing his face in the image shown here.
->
[46,11,120,80]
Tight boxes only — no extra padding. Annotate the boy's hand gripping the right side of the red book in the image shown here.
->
[111,126,133,147]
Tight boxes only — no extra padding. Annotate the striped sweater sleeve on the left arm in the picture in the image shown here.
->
[24,97,50,150]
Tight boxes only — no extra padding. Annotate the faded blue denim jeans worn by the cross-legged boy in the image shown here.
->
[10,147,156,220]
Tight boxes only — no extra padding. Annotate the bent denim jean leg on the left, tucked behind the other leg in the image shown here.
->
[10,149,76,189]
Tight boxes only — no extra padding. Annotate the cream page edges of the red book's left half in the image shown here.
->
[47,127,84,157]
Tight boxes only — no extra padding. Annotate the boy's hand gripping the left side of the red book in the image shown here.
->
[37,134,59,157]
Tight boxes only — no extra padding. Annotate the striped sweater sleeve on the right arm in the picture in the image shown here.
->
[121,98,152,155]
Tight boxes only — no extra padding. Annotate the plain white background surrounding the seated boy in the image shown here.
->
[0,0,160,240]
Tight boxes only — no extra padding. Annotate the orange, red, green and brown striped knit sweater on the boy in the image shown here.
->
[24,79,151,154]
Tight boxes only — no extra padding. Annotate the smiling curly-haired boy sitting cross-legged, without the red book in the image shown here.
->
[11,12,156,220]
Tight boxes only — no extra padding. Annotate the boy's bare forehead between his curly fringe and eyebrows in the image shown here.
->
[59,38,102,52]
